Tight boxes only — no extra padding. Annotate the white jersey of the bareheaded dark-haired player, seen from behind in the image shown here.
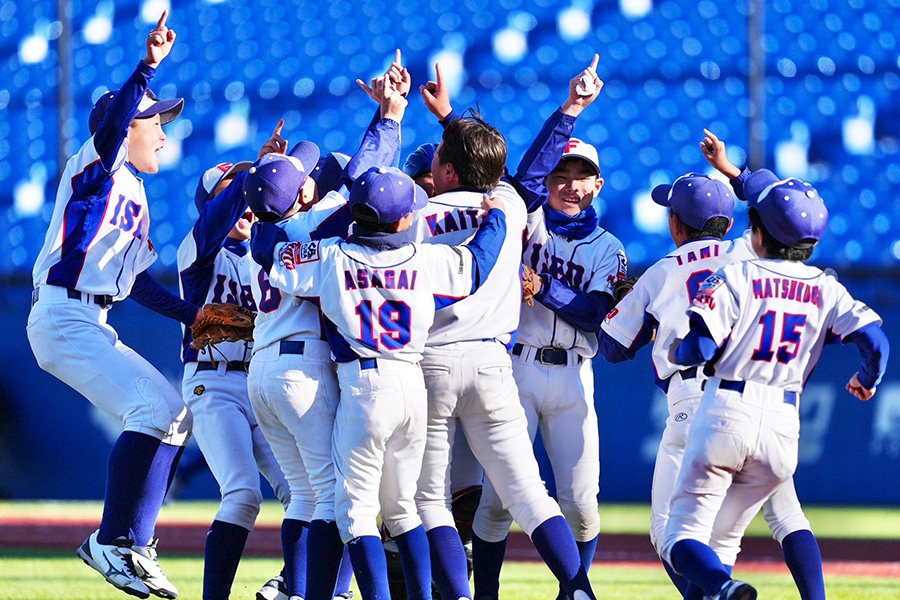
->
[412,182,526,346]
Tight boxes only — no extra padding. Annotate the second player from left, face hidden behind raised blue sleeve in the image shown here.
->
[178,144,290,600]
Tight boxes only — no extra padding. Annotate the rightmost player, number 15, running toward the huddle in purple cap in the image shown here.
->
[662,169,888,600]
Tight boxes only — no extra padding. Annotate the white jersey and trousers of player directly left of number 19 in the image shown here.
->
[245,192,346,522]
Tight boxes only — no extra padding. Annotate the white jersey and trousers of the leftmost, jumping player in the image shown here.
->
[28,110,191,445]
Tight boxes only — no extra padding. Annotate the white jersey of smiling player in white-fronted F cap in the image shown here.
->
[518,210,628,357]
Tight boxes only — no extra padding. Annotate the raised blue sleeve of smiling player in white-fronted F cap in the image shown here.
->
[512,109,575,212]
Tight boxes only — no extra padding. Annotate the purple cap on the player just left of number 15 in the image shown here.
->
[650,173,734,229]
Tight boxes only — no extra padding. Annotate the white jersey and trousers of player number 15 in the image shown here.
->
[662,259,881,560]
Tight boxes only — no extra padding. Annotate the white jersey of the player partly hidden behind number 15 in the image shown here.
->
[601,238,756,380]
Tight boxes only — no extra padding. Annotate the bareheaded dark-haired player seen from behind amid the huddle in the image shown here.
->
[414,66,593,598]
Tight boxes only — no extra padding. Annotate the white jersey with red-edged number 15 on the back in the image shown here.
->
[689,259,881,393]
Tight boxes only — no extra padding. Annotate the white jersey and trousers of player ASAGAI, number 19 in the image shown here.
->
[269,238,474,543]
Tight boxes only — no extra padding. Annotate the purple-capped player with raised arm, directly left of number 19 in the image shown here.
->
[244,68,405,600]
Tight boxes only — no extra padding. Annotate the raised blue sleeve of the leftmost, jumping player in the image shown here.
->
[86,60,156,190]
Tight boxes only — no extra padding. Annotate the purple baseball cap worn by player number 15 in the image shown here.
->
[744,169,828,248]
